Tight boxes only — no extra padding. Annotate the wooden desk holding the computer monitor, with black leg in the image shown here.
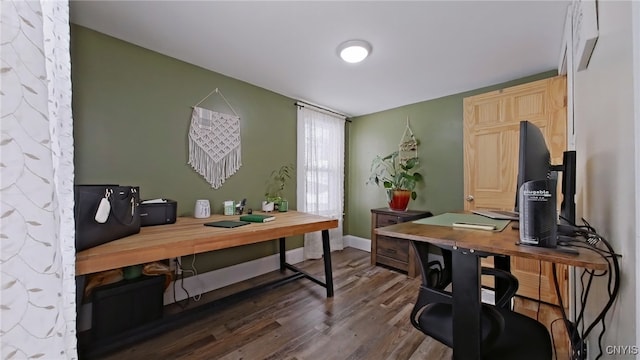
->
[375,222,608,359]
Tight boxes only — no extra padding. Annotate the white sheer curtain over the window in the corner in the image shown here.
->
[296,106,345,259]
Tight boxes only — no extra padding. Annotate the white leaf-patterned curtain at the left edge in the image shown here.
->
[0,0,78,359]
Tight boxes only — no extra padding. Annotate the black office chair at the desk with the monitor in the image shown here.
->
[411,241,553,360]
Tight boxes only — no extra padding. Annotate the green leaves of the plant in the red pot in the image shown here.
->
[367,151,423,200]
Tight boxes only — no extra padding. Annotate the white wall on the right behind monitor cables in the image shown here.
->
[574,1,640,359]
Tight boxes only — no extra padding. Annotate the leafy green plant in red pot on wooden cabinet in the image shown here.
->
[367,151,422,211]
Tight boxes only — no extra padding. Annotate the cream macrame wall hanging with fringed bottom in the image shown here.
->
[189,88,242,189]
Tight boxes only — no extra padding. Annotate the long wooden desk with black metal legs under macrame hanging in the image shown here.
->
[76,211,338,357]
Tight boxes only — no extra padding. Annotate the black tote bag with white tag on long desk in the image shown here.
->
[74,185,140,251]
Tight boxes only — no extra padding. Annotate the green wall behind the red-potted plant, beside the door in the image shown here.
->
[345,70,557,239]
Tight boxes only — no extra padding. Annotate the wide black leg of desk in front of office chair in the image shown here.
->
[452,249,482,360]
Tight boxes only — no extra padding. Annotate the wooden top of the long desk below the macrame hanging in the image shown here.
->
[76,211,338,275]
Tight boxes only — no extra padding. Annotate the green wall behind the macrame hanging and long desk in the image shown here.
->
[71,25,302,271]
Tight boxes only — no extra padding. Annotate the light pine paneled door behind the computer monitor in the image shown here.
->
[464,76,568,304]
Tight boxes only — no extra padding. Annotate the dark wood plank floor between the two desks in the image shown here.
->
[95,248,451,360]
